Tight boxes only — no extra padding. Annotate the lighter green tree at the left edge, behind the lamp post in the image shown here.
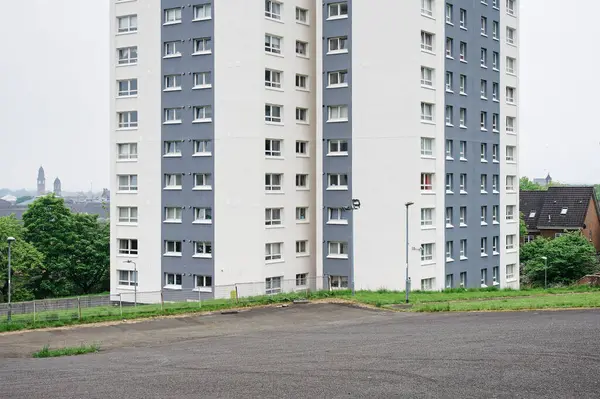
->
[0,216,43,302]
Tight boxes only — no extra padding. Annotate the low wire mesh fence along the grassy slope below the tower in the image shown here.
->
[0,275,335,331]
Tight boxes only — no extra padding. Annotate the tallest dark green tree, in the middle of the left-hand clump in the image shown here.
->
[23,194,76,298]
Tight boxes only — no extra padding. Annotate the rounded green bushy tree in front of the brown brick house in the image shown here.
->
[520,232,598,286]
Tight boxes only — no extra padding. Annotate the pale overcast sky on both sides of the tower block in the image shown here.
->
[0,0,600,191]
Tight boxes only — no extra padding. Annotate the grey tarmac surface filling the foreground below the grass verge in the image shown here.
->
[0,304,600,399]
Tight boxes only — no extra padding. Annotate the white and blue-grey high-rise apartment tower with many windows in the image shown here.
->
[110,0,519,300]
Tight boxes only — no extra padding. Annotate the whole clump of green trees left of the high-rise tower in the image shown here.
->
[0,194,110,302]
